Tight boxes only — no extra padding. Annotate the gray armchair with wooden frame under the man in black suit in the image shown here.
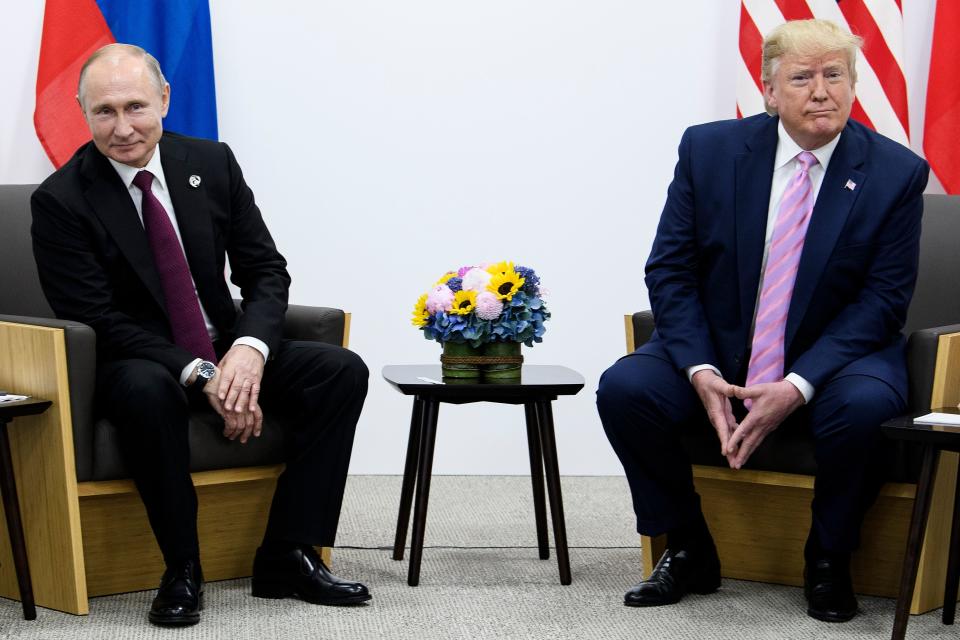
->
[0,185,350,614]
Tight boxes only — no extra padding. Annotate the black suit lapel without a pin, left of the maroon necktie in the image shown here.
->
[80,144,166,312]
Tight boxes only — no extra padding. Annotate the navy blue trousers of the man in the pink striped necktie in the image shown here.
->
[597,353,905,552]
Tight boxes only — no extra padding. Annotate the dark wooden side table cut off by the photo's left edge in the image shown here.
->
[0,398,51,620]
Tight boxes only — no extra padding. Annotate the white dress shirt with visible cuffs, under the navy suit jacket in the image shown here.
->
[687,121,843,402]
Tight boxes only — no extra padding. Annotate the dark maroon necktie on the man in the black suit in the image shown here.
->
[133,171,217,362]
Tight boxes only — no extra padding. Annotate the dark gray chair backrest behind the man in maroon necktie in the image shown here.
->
[0,184,54,318]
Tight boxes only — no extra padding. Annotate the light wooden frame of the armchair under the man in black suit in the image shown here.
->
[0,313,350,615]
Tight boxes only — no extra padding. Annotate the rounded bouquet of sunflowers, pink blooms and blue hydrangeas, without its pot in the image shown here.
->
[413,262,550,347]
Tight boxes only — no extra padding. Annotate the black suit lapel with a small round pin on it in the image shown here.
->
[160,137,217,300]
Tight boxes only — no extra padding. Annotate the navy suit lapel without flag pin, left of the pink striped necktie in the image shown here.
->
[735,118,779,326]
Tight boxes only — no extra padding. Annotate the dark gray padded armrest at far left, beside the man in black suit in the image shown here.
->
[0,315,97,480]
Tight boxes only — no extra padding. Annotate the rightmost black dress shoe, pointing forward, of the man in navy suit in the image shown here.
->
[803,554,857,622]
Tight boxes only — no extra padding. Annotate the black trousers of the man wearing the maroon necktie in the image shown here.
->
[97,340,369,564]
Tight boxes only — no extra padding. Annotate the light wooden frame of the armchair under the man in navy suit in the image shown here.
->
[624,315,960,614]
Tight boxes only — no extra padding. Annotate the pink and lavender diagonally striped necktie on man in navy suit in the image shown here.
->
[744,151,817,409]
